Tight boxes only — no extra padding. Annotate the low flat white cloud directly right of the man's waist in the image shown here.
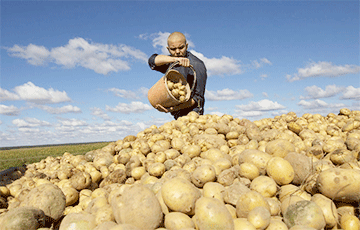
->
[205,88,253,101]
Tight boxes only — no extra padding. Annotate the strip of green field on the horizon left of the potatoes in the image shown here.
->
[0,142,109,171]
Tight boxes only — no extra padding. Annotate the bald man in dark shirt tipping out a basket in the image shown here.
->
[149,32,207,119]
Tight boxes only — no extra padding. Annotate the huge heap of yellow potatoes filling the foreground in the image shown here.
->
[0,109,360,230]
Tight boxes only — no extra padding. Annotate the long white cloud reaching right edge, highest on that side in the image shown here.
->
[286,61,360,82]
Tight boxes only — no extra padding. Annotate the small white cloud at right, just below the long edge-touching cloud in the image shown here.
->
[300,85,344,99]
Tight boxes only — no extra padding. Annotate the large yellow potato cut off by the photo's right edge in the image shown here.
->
[317,168,360,202]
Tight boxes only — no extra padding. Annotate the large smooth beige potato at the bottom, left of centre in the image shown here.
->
[110,184,163,229]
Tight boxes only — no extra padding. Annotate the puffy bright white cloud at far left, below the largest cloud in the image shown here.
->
[14,82,71,104]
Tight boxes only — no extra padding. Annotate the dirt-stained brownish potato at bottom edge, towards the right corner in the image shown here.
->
[284,200,326,230]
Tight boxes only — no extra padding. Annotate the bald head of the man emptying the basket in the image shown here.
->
[167,32,188,57]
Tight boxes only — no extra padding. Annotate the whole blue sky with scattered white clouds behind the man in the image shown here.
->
[0,0,360,147]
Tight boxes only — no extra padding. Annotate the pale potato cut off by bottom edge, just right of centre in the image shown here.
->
[195,197,234,230]
